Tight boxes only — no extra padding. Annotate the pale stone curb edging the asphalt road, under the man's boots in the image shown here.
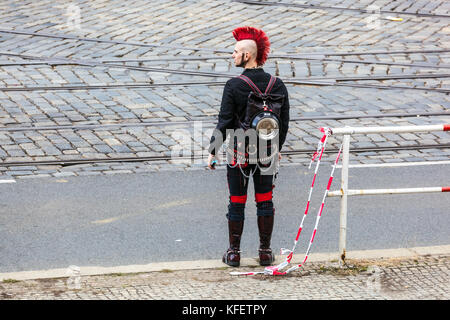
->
[0,245,450,281]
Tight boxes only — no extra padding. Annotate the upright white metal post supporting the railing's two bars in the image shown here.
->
[339,134,350,267]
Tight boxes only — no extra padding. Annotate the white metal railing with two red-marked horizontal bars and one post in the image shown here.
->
[327,124,450,265]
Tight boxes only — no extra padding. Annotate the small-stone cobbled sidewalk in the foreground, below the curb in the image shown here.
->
[0,255,450,300]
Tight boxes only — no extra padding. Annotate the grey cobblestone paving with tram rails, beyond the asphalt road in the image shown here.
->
[0,0,450,180]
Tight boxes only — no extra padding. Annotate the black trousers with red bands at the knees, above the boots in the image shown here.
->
[227,164,275,221]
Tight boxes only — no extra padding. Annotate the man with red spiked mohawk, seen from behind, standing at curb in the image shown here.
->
[208,27,289,267]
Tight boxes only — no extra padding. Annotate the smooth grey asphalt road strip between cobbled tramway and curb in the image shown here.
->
[0,163,450,272]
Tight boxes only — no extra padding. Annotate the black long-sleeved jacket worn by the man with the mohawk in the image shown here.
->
[208,68,289,154]
